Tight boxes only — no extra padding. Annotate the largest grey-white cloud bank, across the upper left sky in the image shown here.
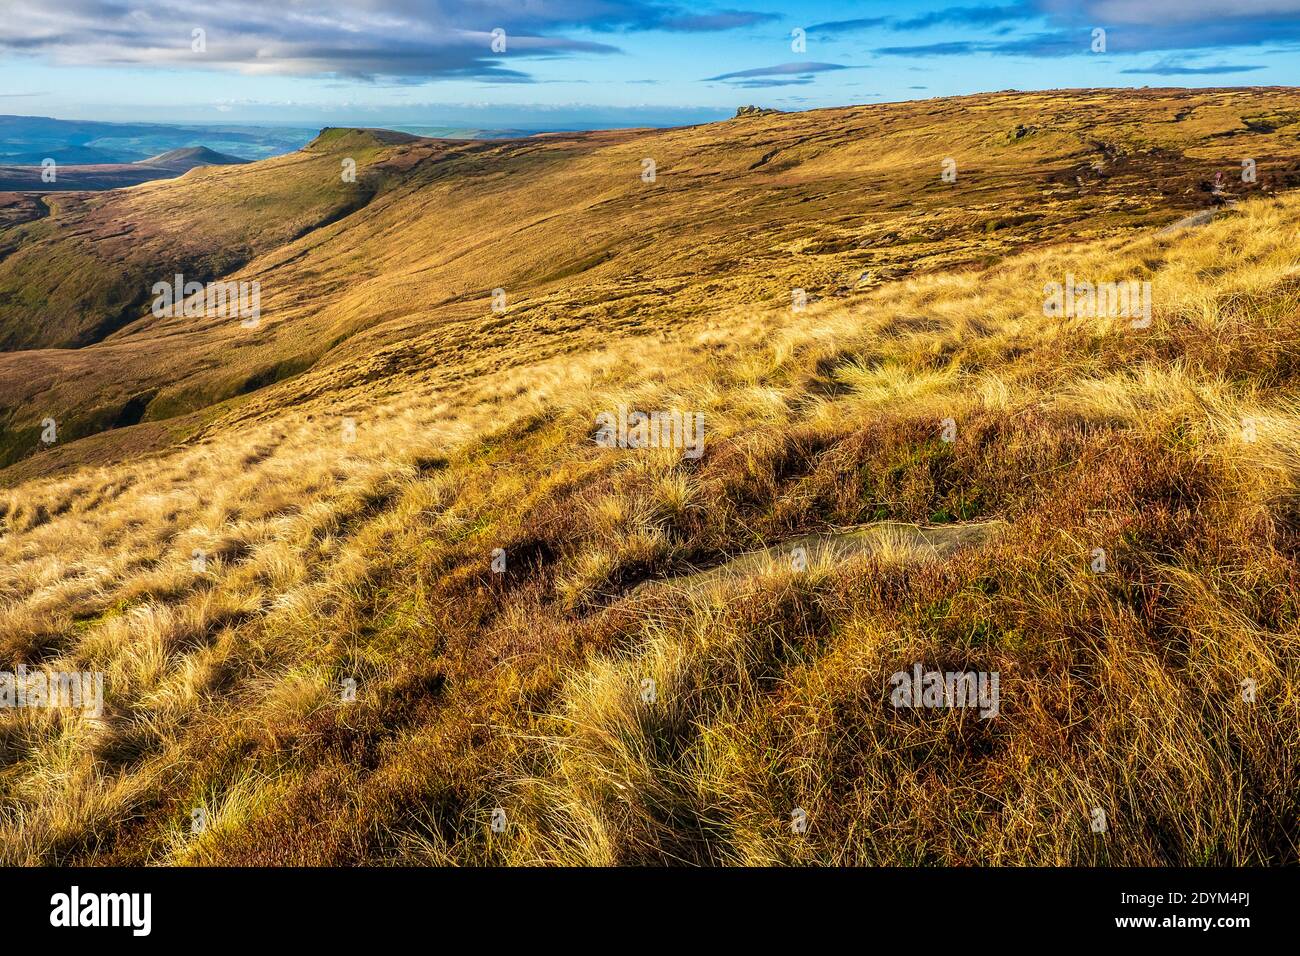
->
[0,0,774,82]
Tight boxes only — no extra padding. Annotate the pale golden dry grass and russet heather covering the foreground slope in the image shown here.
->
[0,111,1300,865]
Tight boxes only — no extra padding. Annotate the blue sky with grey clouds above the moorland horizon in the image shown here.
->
[0,0,1300,129]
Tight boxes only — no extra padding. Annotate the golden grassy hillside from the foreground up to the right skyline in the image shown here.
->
[0,91,1300,865]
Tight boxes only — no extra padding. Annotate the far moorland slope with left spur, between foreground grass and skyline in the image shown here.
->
[0,90,1300,473]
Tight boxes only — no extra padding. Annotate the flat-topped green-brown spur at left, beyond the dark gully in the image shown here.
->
[0,127,410,350]
